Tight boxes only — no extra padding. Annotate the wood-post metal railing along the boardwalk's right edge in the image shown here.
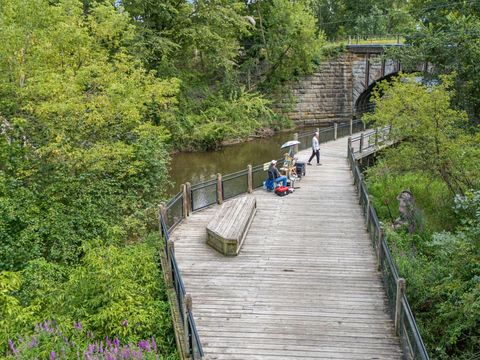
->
[348,129,429,360]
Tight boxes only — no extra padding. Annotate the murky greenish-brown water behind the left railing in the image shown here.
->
[168,127,320,195]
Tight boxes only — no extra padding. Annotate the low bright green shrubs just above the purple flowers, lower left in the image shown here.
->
[0,243,175,355]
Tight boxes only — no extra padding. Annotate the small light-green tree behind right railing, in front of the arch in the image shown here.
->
[364,76,480,195]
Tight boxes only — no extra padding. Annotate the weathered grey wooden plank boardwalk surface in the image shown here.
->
[171,138,402,360]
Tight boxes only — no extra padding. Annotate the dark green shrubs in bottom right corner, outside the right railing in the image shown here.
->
[382,191,480,359]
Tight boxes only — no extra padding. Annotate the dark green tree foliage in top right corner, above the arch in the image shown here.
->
[389,0,480,124]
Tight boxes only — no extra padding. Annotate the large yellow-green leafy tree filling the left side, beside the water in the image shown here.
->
[0,0,178,269]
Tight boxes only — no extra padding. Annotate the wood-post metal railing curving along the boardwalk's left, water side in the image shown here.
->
[159,120,365,360]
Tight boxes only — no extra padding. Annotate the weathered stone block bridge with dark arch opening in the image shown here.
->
[278,45,424,125]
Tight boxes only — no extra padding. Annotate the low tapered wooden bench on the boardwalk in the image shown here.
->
[207,196,257,256]
